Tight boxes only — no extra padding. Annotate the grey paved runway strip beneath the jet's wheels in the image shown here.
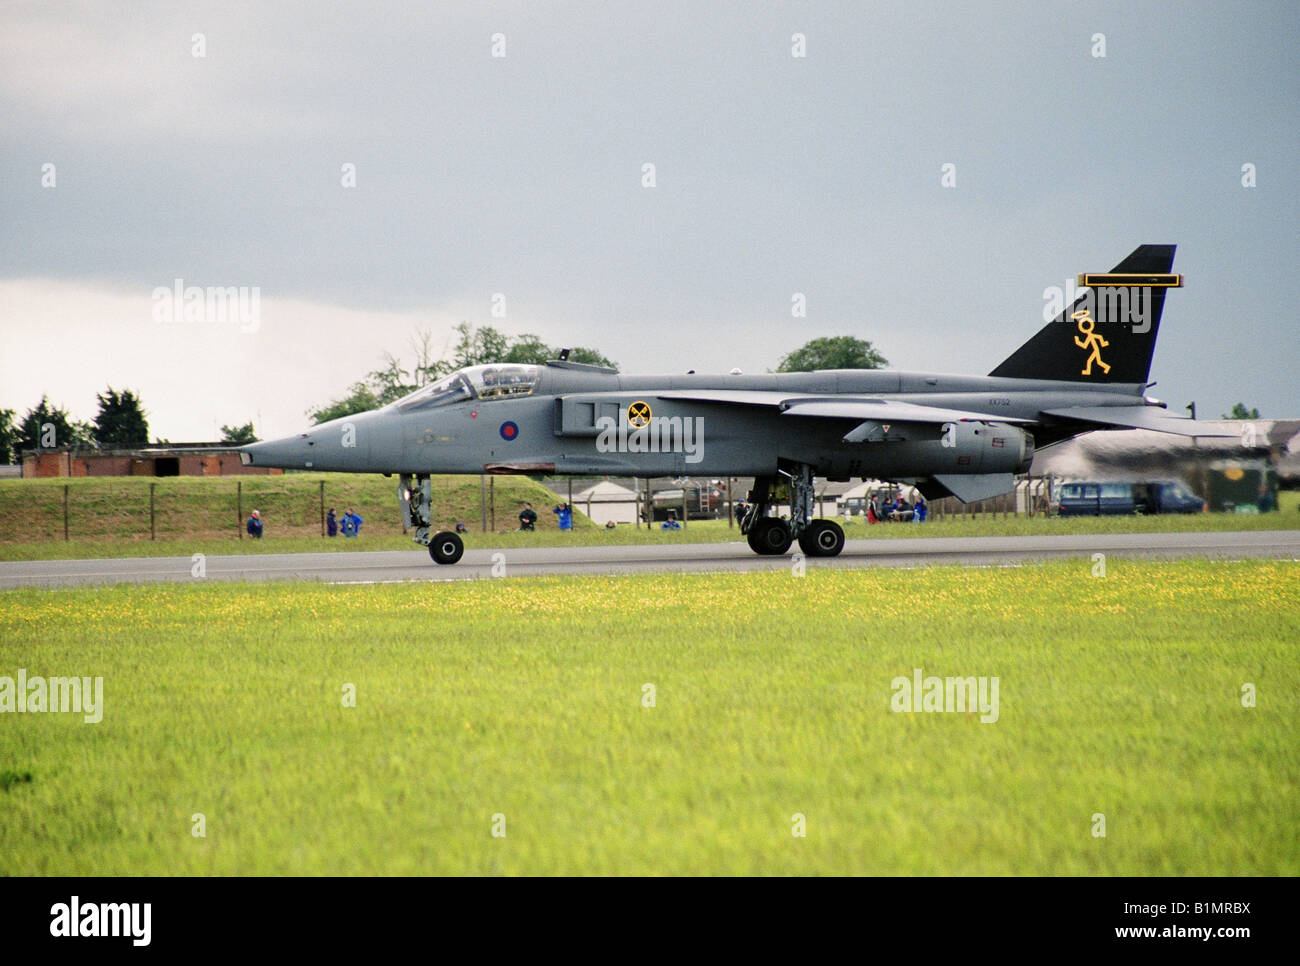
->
[0,530,1300,589]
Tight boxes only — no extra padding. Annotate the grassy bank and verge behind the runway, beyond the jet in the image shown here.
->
[0,473,1300,560]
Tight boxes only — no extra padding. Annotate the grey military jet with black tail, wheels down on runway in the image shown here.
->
[242,244,1223,564]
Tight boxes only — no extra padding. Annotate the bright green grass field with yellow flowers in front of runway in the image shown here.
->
[0,559,1300,875]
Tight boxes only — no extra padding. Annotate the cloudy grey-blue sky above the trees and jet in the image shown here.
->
[0,0,1300,441]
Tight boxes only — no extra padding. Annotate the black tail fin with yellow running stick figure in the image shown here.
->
[989,244,1175,384]
